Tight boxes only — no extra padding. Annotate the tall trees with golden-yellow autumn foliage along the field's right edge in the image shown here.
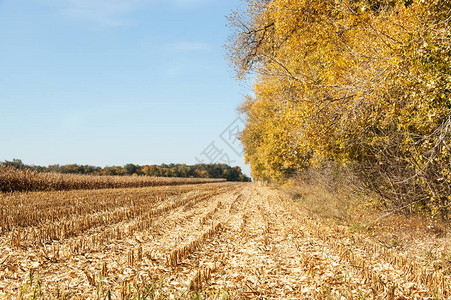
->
[228,0,451,215]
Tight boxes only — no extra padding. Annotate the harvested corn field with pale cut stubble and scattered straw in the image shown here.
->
[0,183,451,299]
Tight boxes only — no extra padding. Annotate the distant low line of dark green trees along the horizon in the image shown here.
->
[0,159,251,181]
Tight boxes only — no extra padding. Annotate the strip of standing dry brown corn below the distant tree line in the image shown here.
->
[0,166,226,193]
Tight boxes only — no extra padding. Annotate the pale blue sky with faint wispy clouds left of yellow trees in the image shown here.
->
[0,0,249,174]
